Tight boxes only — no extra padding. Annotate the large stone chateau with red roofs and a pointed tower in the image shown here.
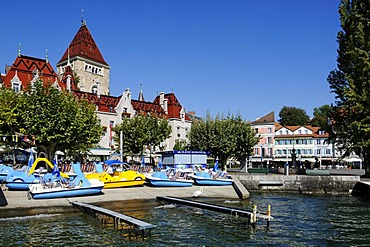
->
[0,21,191,160]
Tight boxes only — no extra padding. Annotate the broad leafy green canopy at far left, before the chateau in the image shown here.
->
[0,81,102,159]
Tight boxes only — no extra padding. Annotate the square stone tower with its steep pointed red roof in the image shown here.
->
[57,20,110,95]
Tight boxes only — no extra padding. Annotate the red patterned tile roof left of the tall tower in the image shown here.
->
[3,55,60,90]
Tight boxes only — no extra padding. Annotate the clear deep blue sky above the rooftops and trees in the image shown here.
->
[0,0,340,120]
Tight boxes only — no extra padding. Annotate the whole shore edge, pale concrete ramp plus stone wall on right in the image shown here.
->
[0,173,361,217]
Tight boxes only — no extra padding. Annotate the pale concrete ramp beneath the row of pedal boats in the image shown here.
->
[0,185,239,217]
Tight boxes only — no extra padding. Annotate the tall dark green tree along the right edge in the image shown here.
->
[328,0,370,171]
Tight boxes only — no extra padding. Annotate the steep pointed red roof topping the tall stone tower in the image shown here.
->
[58,24,108,66]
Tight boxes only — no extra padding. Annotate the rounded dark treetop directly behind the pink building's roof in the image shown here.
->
[278,106,310,126]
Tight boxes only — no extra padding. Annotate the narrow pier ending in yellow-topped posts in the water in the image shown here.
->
[157,196,273,226]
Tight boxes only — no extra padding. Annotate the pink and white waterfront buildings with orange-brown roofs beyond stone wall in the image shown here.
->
[251,112,340,166]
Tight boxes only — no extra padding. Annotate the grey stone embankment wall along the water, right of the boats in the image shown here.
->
[234,173,360,194]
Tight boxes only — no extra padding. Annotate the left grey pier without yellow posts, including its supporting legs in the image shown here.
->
[71,201,155,236]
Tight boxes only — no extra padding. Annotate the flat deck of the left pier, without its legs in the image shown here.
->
[71,201,154,230]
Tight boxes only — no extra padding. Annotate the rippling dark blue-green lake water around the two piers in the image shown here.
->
[0,193,370,246]
